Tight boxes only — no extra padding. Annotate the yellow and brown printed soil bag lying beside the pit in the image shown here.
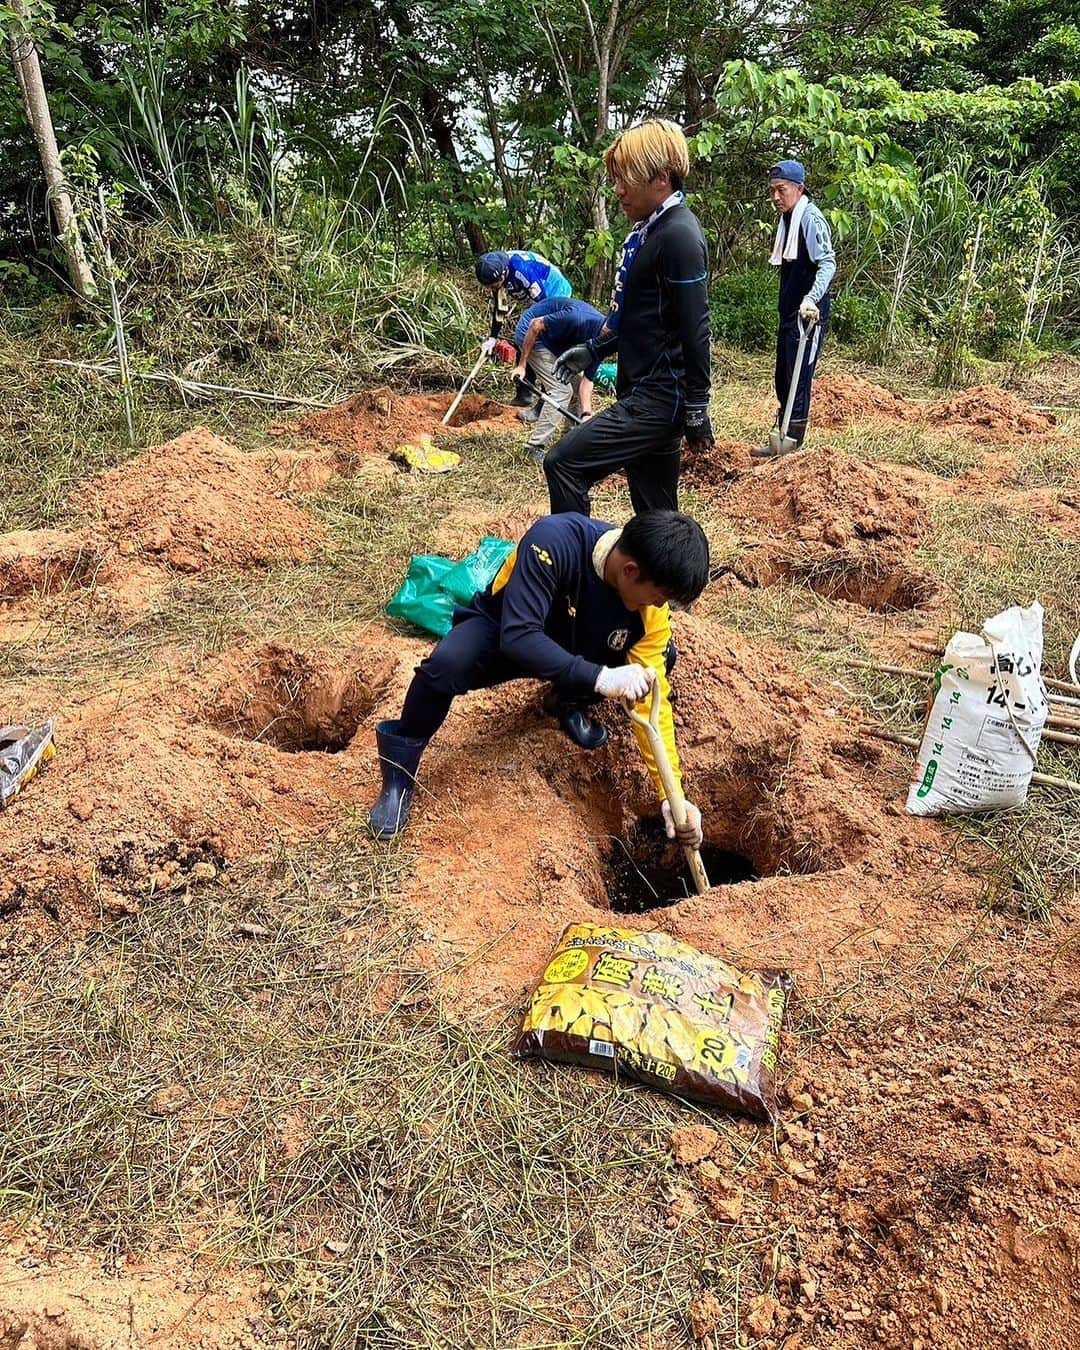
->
[512,923,791,1122]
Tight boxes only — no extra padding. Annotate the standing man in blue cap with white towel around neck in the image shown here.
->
[751,159,836,459]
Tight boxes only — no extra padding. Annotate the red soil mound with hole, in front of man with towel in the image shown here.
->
[716,447,937,610]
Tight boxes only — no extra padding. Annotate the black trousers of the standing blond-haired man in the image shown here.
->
[544,394,682,516]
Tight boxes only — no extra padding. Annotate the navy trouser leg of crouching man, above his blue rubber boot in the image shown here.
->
[400,614,527,741]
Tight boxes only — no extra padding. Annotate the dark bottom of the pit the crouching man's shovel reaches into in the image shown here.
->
[605,815,760,914]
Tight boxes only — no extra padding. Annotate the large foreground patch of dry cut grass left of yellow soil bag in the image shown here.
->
[0,832,759,1347]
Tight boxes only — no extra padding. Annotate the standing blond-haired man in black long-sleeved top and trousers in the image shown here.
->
[544,119,713,516]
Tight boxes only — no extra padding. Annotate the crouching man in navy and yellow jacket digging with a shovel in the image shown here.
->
[370,510,709,848]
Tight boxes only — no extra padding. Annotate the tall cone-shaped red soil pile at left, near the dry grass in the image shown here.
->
[80,427,325,572]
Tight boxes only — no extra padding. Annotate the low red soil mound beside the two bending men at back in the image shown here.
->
[300,389,514,454]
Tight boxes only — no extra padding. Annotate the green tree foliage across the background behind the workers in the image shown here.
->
[0,0,1080,353]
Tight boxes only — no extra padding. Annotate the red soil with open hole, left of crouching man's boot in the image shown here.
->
[0,640,402,932]
